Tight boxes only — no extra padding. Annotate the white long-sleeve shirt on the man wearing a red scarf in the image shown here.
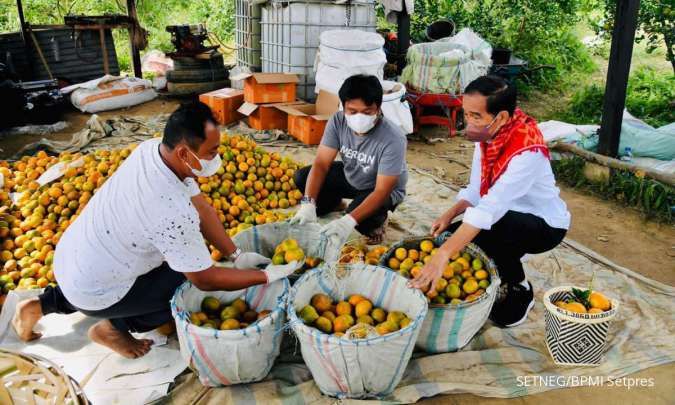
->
[457,143,570,229]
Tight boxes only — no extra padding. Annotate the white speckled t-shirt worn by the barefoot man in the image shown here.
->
[54,139,213,310]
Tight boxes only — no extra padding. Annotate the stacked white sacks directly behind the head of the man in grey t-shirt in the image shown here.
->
[314,30,387,94]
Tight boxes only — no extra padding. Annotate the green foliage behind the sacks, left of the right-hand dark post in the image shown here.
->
[404,0,595,90]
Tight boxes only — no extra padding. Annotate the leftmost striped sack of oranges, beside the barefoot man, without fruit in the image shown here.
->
[171,279,290,387]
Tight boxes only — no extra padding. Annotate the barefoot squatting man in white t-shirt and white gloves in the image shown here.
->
[13,103,294,358]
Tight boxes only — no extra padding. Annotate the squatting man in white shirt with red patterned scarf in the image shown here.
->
[410,76,570,327]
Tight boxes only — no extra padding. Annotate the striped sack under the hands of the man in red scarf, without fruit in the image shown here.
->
[380,232,501,353]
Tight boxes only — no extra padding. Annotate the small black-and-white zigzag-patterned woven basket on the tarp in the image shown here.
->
[544,286,619,366]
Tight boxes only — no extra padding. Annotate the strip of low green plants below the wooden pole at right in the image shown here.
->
[552,157,675,223]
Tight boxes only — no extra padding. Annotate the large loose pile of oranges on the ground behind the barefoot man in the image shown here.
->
[0,135,302,304]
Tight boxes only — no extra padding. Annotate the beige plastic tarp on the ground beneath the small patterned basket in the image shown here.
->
[164,163,675,405]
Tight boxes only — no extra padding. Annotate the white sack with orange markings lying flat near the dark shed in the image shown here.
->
[61,75,157,113]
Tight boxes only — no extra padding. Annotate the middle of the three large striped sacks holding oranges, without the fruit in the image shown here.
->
[288,264,427,398]
